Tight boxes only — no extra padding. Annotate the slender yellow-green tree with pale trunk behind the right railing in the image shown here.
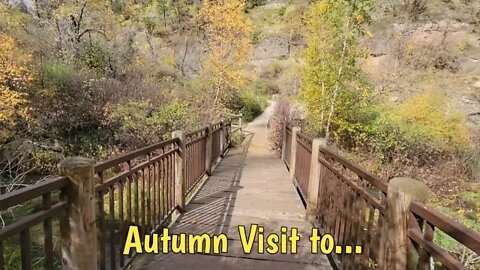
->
[301,0,370,142]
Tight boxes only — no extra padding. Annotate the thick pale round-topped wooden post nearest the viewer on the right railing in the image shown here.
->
[384,177,428,270]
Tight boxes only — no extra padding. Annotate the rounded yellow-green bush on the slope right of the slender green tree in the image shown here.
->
[356,92,472,163]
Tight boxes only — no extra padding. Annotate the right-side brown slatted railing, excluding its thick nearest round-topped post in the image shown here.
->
[282,125,480,269]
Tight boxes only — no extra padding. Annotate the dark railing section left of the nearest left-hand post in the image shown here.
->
[0,177,69,269]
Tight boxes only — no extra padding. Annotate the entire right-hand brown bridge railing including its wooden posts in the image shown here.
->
[282,126,480,269]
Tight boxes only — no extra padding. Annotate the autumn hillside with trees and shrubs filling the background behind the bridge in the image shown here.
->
[0,0,480,269]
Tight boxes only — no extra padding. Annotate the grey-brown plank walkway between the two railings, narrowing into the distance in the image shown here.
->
[133,103,331,270]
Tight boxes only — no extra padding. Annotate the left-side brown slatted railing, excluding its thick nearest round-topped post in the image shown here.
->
[0,120,242,270]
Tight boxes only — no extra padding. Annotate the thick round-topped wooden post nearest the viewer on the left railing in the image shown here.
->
[58,157,97,270]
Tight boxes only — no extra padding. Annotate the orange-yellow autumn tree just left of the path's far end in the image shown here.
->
[199,0,252,120]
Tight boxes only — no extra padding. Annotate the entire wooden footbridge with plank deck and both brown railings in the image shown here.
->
[0,103,480,270]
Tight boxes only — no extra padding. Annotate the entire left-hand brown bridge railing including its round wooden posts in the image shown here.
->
[0,118,240,270]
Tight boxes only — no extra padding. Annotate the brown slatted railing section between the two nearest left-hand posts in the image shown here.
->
[94,138,180,269]
